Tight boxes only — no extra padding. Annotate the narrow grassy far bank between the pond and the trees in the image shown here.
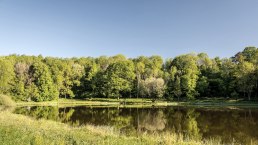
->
[16,98,258,107]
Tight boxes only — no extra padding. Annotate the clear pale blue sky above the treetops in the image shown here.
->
[0,0,258,58]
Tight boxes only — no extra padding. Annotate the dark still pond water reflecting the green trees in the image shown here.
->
[14,106,258,144]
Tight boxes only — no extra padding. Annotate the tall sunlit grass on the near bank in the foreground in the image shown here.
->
[0,111,224,145]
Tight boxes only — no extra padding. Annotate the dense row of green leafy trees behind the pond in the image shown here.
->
[0,47,258,101]
